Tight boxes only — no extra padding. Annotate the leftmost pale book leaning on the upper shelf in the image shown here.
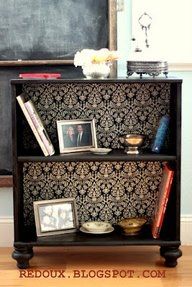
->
[16,95,49,156]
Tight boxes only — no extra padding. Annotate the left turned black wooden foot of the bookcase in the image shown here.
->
[12,246,33,269]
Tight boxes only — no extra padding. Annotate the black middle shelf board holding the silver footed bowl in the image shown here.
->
[18,150,176,162]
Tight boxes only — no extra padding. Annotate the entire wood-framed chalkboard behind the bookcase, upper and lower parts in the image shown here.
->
[0,0,116,180]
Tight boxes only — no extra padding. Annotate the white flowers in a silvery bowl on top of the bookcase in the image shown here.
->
[74,48,118,78]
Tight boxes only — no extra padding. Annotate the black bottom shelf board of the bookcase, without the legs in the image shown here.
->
[15,231,180,246]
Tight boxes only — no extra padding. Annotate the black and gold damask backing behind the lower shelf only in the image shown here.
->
[23,161,162,226]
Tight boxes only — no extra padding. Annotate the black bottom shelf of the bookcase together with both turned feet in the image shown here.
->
[12,231,182,269]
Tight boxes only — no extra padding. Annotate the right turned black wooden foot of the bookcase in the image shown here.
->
[160,246,182,267]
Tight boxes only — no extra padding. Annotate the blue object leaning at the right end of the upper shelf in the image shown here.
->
[151,115,170,153]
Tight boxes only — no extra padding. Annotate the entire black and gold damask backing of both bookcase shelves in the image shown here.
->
[21,81,170,226]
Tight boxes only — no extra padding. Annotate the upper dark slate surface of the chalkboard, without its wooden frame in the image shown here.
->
[0,0,109,61]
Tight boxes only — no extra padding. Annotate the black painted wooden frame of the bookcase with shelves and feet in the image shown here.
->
[11,78,182,268]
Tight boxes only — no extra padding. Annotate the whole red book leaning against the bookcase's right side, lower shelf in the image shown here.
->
[152,165,174,238]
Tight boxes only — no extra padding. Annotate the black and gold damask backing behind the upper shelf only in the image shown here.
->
[23,81,170,149]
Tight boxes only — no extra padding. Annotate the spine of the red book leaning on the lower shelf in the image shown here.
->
[152,170,174,239]
